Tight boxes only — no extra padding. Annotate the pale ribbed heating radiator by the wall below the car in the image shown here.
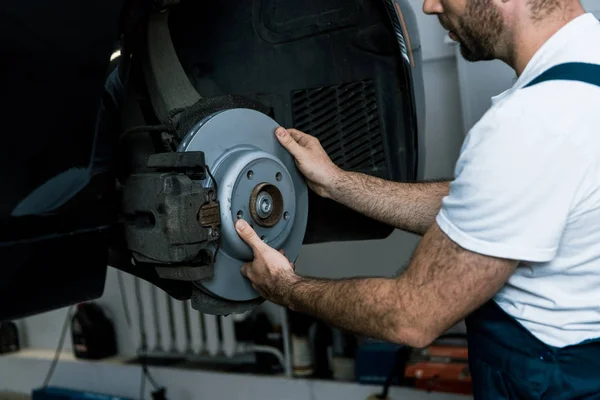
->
[117,271,292,376]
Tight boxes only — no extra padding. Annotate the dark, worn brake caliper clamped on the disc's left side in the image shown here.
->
[122,151,221,281]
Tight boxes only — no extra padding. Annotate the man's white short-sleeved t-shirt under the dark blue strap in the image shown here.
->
[437,13,600,347]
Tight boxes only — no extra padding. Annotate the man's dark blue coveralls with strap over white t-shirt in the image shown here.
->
[466,63,600,400]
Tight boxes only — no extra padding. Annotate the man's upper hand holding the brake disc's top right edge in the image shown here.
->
[275,127,344,198]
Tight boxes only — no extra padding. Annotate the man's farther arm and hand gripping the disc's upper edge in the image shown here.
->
[277,128,450,235]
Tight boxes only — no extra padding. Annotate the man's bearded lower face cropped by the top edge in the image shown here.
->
[423,0,504,61]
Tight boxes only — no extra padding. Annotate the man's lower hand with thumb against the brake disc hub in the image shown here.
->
[235,219,301,307]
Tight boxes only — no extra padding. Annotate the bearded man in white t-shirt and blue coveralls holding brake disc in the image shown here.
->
[236,0,600,399]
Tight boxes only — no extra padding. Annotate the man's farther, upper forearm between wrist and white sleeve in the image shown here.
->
[330,172,450,235]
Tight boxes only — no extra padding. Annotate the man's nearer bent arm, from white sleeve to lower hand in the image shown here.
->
[236,221,517,347]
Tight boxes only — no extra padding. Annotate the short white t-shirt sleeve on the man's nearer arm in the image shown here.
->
[436,103,580,262]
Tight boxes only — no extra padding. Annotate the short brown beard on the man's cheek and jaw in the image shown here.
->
[454,0,504,62]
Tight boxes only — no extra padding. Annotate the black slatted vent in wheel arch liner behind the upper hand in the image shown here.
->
[292,80,385,170]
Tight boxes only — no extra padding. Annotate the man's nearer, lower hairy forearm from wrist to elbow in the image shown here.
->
[288,278,426,347]
